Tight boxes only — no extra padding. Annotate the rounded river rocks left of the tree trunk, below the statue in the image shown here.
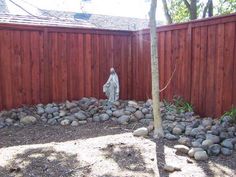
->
[0,98,153,128]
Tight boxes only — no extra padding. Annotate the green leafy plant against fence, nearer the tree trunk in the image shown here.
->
[173,96,193,113]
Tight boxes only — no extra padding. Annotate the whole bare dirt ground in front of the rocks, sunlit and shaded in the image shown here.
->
[0,122,236,177]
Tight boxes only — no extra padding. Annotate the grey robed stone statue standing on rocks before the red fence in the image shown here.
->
[103,68,120,102]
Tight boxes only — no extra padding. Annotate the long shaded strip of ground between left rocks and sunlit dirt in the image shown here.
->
[0,121,139,148]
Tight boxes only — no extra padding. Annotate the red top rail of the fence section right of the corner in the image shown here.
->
[133,13,236,35]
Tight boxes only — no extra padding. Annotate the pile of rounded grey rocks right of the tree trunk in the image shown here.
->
[162,105,236,160]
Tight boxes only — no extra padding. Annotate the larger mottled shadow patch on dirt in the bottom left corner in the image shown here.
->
[0,147,91,177]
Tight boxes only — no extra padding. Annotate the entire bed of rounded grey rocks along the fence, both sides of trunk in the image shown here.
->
[0,98,236,160]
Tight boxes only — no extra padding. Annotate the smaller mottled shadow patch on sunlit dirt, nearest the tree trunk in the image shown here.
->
[101,143,154,176]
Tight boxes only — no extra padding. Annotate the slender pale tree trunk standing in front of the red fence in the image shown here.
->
[149,0,164,138]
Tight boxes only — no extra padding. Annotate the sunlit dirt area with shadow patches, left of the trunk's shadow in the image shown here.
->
[0,133,159,177]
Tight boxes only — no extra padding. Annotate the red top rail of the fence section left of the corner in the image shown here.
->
[0,23,132,35]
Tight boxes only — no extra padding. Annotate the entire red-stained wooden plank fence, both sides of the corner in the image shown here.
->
[0,14,236,116]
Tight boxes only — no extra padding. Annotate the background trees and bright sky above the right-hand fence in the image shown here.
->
[162,0,236,24]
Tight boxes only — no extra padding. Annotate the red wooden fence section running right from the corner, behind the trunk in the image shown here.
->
[132,14,236,116]
